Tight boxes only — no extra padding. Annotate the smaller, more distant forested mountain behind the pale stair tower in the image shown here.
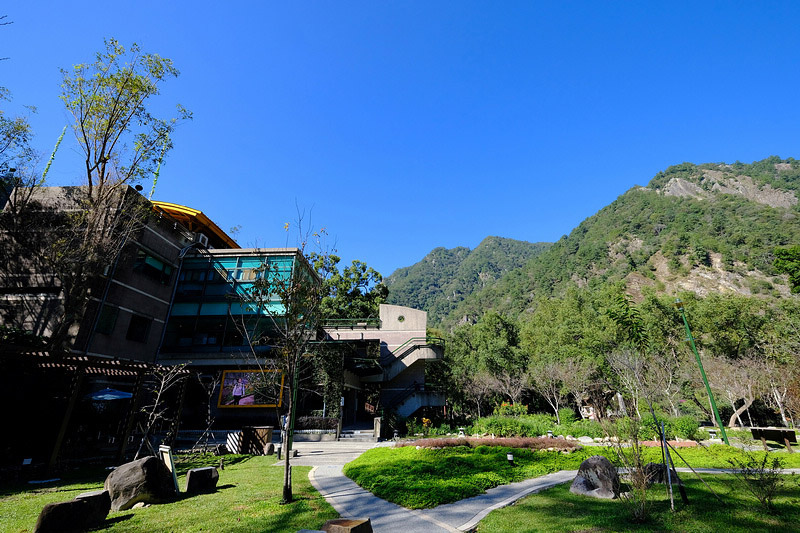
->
[385,237,550,323]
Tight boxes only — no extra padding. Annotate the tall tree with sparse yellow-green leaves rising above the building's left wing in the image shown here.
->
[40,39,190,348]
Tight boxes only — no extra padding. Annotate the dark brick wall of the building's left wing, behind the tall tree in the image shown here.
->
[0,187,192,362]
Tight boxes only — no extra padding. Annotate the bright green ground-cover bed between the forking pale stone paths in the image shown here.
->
[344,445,800,509]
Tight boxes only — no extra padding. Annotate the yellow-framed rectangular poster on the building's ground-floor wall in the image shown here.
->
[217,370,284,408]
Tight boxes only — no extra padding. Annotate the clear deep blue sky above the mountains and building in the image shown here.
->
[0,4,800,275]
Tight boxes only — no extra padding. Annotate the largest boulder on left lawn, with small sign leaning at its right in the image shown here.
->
[104,456,176,511]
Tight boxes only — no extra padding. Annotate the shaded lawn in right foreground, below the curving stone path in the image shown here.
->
[478,474,800,533]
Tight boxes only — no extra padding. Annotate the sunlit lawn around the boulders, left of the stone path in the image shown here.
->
[0,456,339,533]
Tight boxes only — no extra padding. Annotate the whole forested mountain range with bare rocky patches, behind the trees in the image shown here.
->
[389,157,800,326]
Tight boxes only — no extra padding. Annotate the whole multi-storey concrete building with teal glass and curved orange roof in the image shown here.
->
[0,187,443,465]
